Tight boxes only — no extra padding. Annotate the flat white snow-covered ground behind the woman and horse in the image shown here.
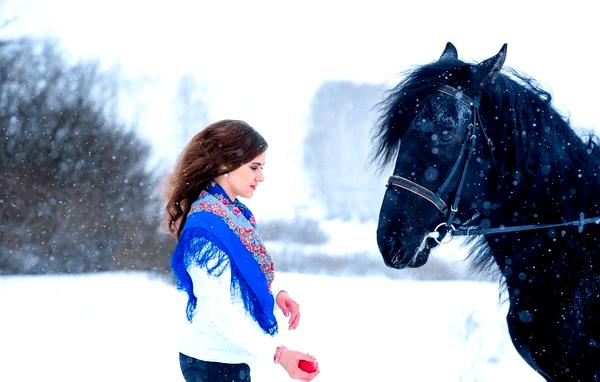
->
[0,273,542,382]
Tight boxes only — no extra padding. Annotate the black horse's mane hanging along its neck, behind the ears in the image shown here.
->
[466,69,600,272]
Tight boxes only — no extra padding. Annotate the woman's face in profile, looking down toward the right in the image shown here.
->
[215,151,266,200]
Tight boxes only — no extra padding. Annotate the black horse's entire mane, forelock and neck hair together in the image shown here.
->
[371,60,600,272]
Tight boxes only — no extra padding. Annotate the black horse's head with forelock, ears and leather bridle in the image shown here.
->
[377,43,506,268]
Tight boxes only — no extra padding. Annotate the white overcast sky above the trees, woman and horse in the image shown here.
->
[0,0,600,215]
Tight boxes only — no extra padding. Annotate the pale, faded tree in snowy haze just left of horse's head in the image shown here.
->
[304,81,385,221]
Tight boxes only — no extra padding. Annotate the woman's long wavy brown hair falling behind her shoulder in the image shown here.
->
[165,119,267,238]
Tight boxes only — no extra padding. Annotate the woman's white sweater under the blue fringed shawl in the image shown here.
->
[180,243,279,367]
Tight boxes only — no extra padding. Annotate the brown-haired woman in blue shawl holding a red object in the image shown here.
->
[166,120,319,382]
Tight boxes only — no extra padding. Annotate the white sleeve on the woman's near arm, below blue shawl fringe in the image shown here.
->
[188,249,279,356]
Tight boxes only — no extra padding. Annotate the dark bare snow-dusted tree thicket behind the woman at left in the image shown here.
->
[0,39,174,274]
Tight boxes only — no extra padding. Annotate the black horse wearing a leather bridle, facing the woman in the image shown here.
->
[374,43,600,382]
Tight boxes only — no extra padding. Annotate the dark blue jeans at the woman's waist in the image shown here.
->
[179,353,250,382]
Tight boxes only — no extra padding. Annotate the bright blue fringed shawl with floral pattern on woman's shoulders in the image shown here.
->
[171,182,277,335]
